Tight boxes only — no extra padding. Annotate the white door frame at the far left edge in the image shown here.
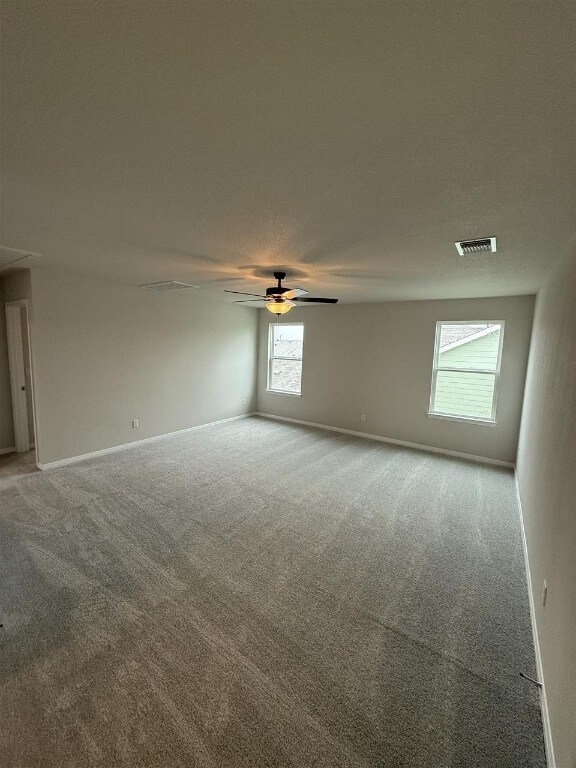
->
[5,299,38,453]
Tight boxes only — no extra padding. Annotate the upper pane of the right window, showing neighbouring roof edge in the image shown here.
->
[438,323,502,371]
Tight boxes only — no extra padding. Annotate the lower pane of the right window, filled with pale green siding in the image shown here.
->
[432,371,496,419]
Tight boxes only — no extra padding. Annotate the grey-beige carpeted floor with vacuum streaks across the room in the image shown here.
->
[0,418,545,768]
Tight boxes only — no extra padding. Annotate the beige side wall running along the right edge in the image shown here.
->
[517,248,576,768]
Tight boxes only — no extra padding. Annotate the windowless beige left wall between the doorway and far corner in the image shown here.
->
[32,269,257,464]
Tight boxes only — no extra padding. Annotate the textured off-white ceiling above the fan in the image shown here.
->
[1,0,576,301]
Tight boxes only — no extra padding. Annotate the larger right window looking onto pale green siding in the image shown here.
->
[429,322,504,423]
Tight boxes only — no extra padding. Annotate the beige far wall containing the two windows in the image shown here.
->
[257,296,534,462]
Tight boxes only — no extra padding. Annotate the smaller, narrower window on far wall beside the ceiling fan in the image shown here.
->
[268,323,304,395]
